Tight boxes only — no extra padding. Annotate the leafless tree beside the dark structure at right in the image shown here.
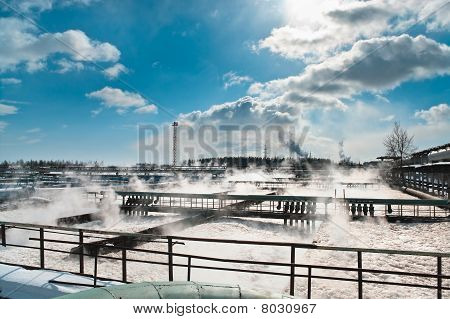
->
[383,122,416,180]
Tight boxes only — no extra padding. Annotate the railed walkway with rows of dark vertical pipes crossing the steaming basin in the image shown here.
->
[111,191,450,218]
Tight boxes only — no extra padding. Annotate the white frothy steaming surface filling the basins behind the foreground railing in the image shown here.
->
[0,172,450,298]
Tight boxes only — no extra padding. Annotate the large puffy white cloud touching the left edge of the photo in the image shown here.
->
[0,17,120,72]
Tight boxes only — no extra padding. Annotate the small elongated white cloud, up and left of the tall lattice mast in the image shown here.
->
[86,86,157,114]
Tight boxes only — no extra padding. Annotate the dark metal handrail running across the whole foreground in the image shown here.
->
[0,222,450,299]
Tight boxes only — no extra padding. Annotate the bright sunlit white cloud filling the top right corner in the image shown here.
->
[255,0,450,62]
